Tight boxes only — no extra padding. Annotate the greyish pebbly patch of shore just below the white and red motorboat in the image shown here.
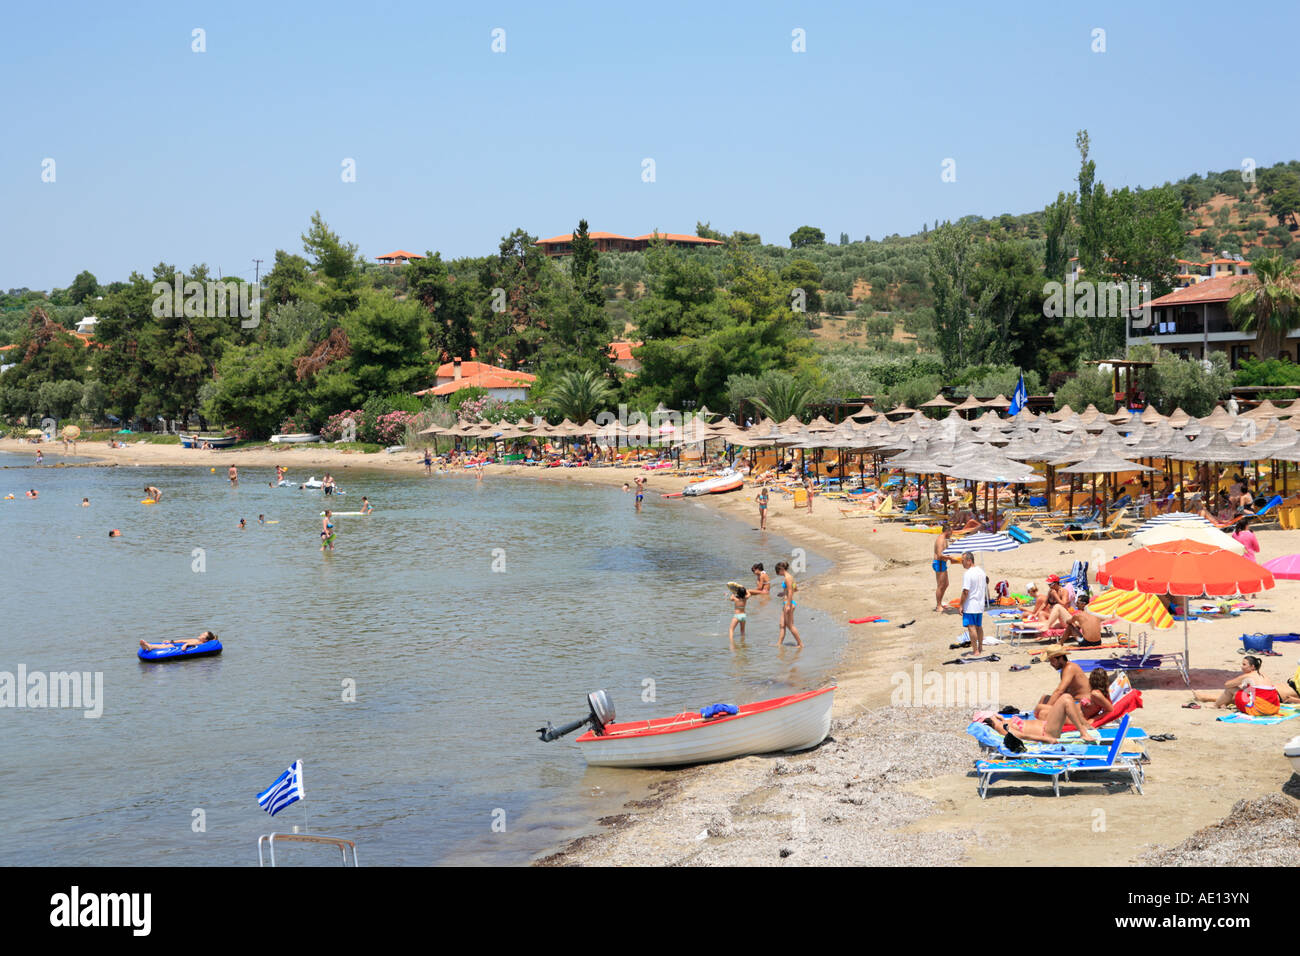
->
[541,708,971,866]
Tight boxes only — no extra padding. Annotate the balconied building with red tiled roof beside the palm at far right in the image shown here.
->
[1127,274,1300,368]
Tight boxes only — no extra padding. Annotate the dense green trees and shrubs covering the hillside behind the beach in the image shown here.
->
[0,141,1300,436]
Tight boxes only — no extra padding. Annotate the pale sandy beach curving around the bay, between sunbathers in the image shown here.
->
[10,440,1300,865]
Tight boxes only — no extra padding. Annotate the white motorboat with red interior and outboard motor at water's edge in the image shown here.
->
[538,684,835,767]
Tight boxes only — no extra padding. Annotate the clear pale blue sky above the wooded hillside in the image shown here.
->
[0,0,1300,289]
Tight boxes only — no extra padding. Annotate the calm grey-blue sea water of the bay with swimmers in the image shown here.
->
[0,455,844,865]
